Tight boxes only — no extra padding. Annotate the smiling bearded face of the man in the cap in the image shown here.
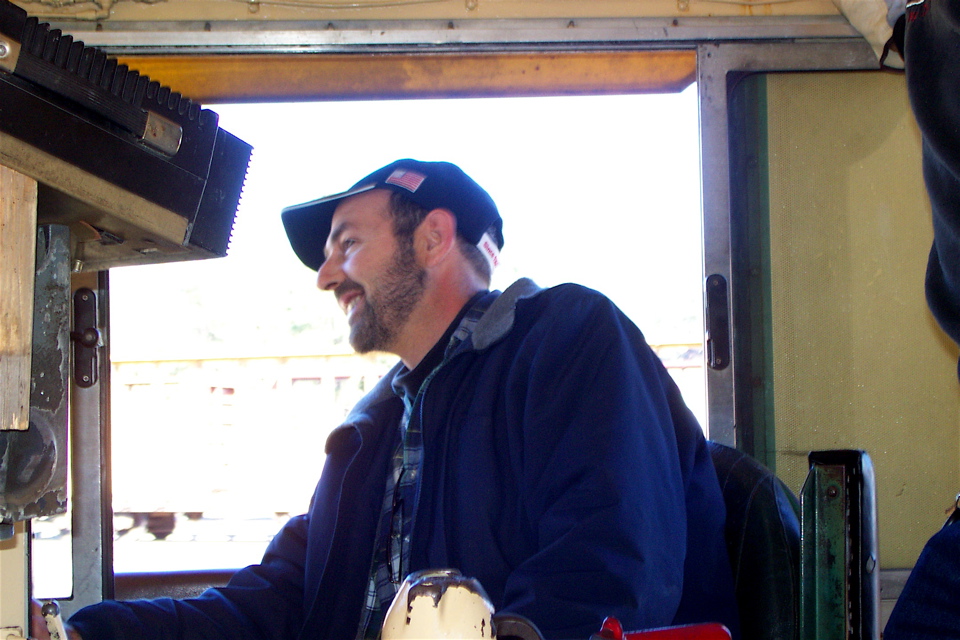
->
[317,190,426,353]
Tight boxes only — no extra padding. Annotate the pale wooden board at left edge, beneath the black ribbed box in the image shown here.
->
[0,166,37,430]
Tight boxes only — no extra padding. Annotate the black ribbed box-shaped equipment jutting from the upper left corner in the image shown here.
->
[0,0,252,271]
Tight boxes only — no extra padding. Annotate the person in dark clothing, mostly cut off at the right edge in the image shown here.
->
[883,6,960,640]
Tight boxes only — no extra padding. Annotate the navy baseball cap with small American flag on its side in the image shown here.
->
[281,159,503,271]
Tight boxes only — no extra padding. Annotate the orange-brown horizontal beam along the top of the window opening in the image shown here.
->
[121,50,697,103]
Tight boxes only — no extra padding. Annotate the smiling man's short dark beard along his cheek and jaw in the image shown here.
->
[350,241,426,353]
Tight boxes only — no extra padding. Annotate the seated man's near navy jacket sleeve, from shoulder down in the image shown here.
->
[503,296,687,638]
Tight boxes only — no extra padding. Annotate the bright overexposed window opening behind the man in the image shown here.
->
[34,86,706,593]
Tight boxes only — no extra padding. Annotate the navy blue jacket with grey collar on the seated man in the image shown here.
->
[70,280,737,640]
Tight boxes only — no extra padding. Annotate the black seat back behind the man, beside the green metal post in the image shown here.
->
[707,442,800,640]
